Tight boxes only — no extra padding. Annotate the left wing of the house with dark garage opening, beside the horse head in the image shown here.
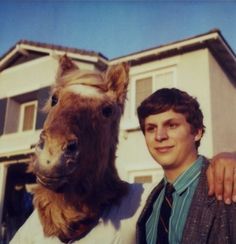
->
[0,41,108,242]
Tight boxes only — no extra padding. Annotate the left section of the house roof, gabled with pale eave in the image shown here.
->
[0,40,108,71]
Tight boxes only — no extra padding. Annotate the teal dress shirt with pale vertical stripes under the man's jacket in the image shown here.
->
[146,156,203,244]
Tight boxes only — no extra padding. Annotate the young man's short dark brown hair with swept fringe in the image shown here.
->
[137,88,205,148]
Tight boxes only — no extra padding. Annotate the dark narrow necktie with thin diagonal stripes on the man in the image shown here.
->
[156,183,175,244]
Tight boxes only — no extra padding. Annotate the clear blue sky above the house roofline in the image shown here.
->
[0,0,236,59]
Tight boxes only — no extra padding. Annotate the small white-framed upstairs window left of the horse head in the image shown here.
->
[19,101,37,131]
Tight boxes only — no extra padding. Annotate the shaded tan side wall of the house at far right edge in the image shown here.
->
[209,54,236,153]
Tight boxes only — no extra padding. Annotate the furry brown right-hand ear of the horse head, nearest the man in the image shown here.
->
[106,63,129,104]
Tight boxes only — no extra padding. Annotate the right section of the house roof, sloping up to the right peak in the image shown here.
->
[109,29,236,80]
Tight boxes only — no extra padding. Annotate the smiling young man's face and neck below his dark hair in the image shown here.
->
[145,110,202,180]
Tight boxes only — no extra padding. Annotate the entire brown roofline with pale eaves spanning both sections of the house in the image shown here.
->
[0,29,236,80]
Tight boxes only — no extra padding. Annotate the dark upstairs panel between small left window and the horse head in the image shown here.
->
[36,87,50,130]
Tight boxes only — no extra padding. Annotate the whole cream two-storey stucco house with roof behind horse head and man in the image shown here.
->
[0,30,236,240]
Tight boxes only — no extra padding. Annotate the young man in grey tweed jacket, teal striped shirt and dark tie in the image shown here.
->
[137,88,236,244]
